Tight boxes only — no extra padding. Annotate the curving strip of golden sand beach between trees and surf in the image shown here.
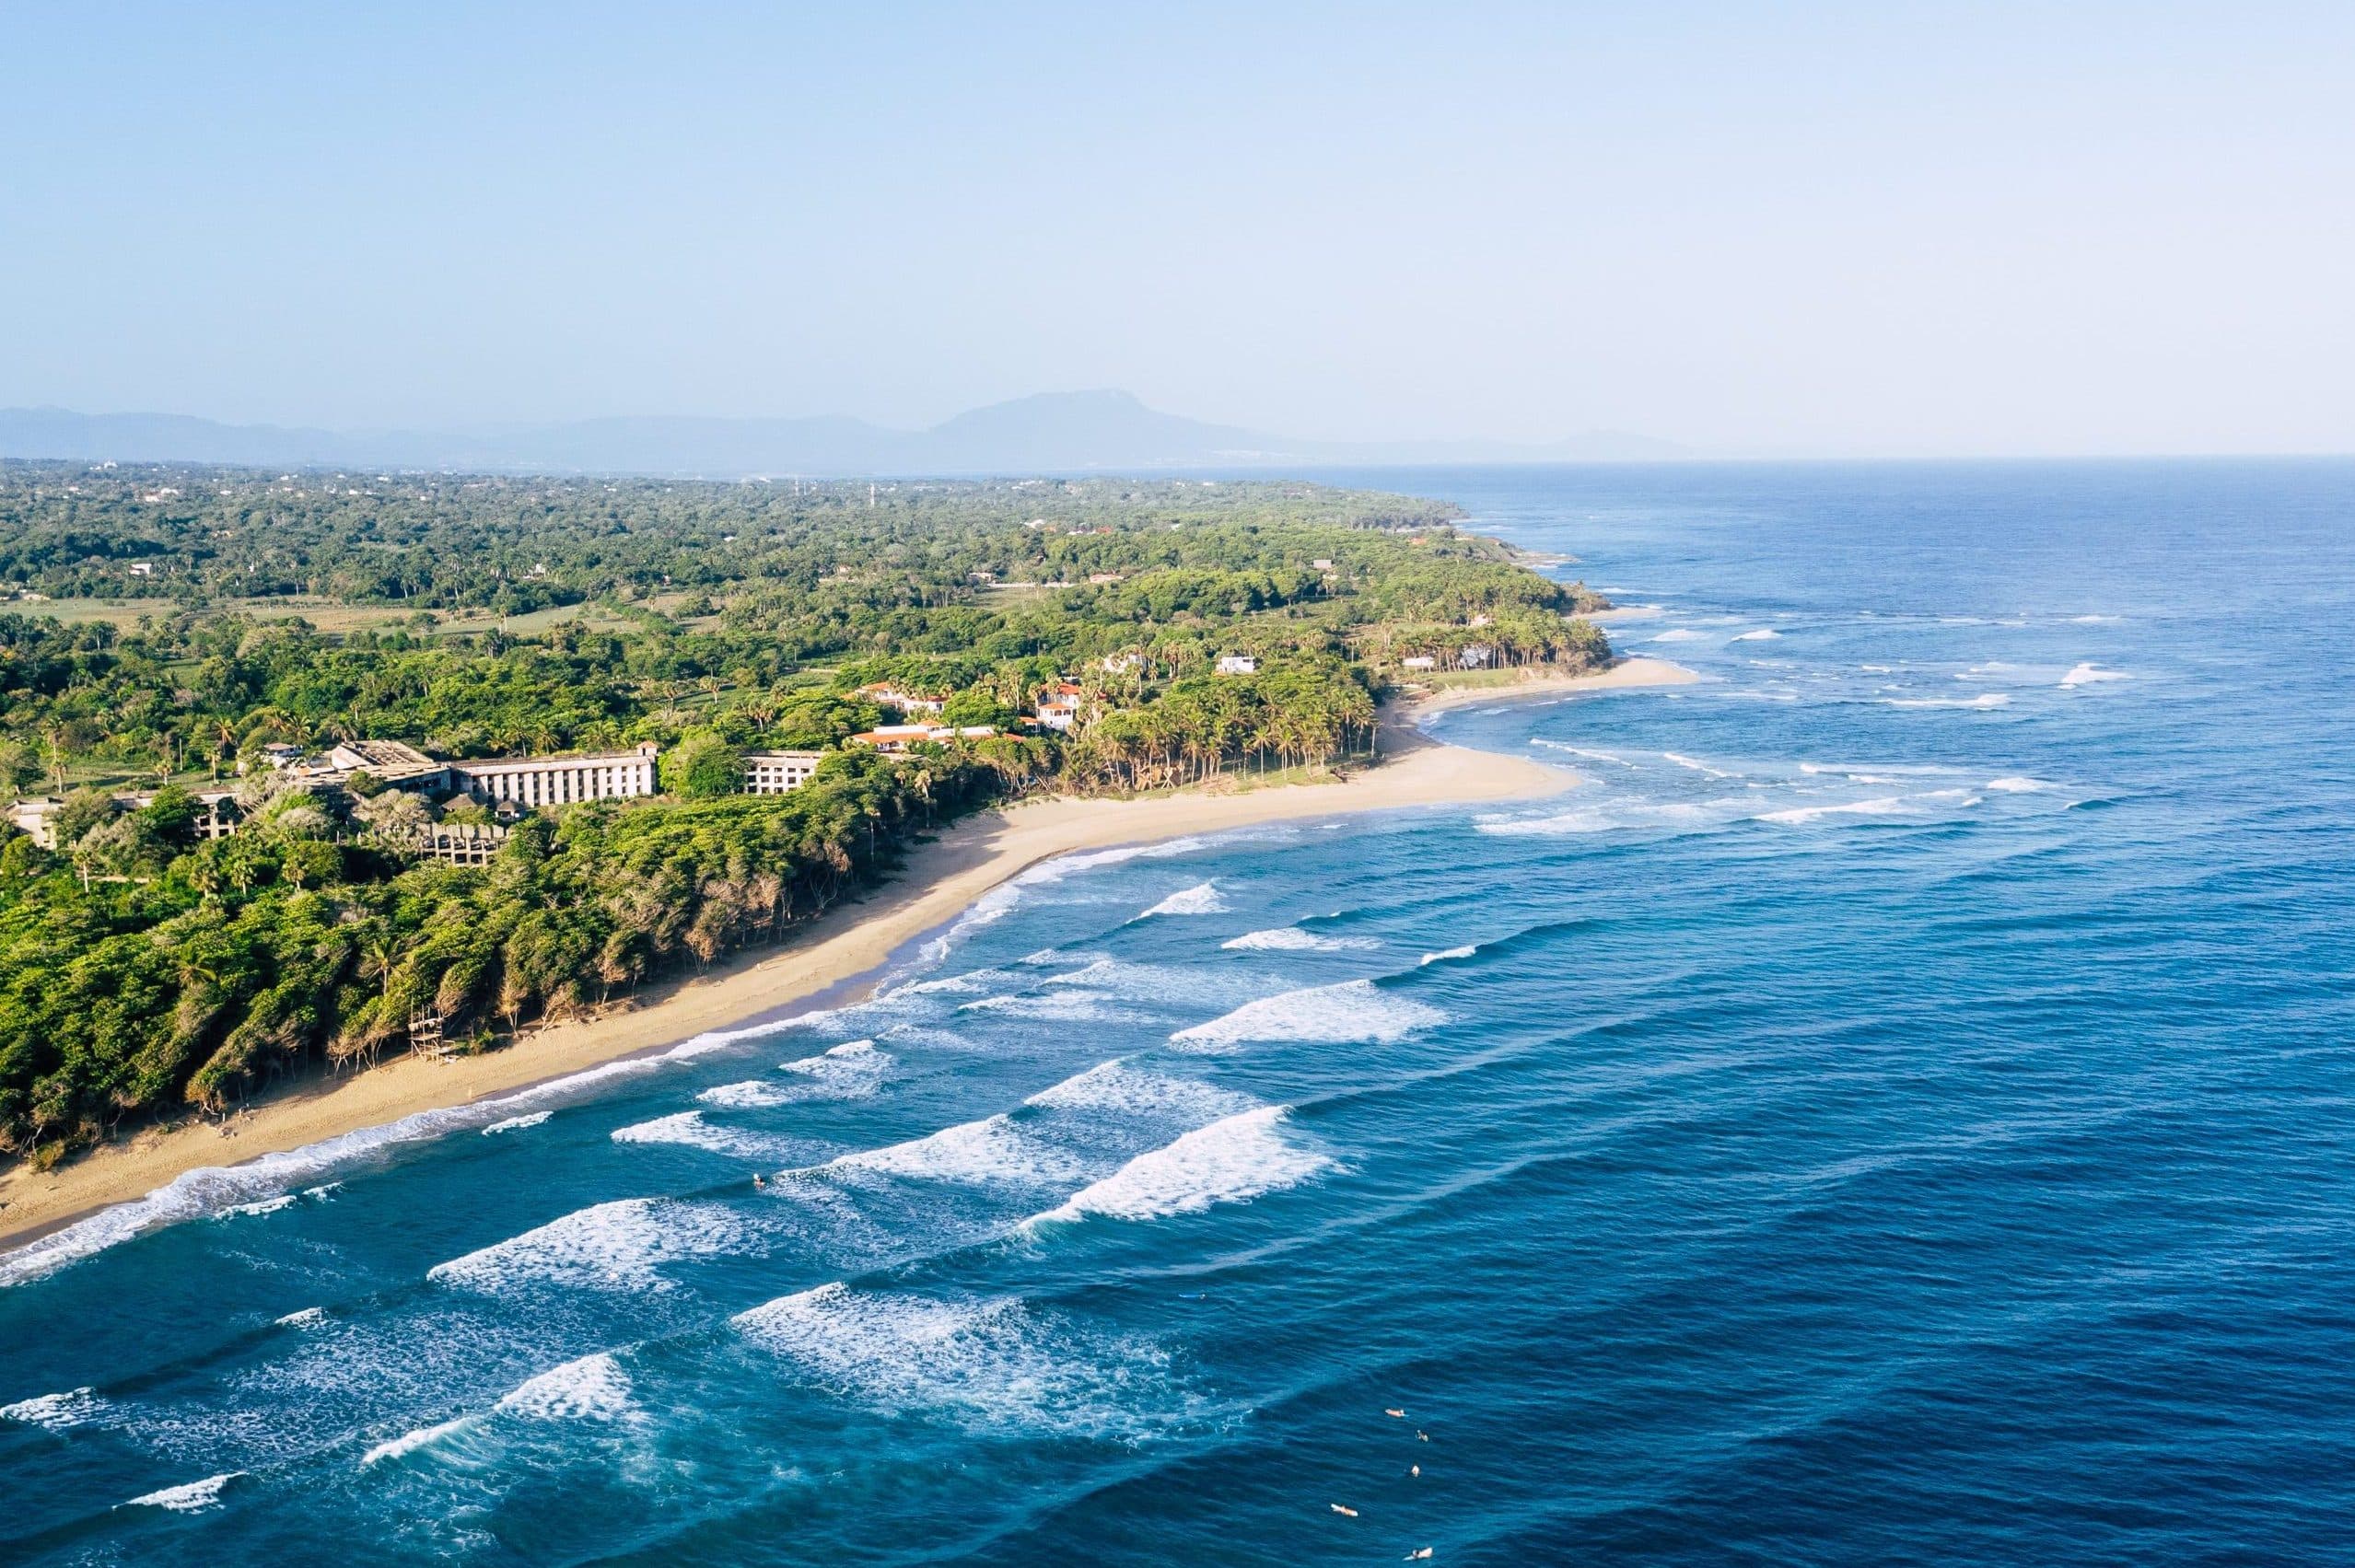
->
[0,659,1693,1248]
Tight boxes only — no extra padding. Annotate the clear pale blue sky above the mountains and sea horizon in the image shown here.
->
[0,3,2355,455]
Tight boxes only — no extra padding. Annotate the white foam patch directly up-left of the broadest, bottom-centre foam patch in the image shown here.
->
[426,1199,744,1290]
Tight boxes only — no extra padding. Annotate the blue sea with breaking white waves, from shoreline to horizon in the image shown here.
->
[0,461,2355,1565]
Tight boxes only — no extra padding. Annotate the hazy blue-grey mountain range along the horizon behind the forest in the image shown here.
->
[0,390,1691,478]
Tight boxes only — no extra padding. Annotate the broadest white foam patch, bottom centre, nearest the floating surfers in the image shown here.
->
[732,1283,1172,1436]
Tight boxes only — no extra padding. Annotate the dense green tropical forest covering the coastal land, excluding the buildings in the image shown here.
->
[0,464,1611,1161]
